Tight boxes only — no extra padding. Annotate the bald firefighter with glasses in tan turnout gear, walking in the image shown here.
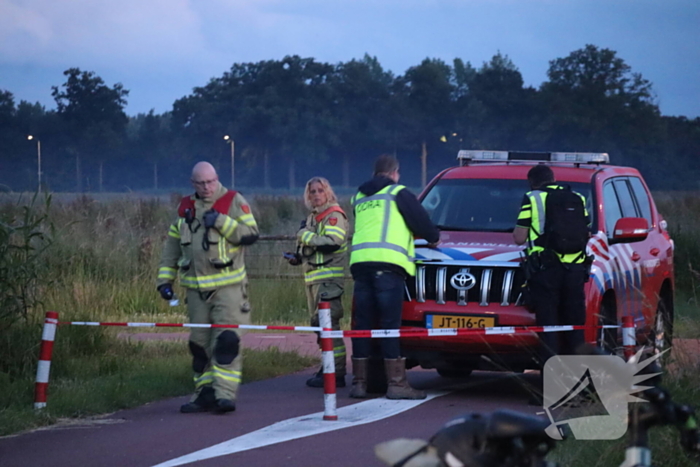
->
[156,162,258,413]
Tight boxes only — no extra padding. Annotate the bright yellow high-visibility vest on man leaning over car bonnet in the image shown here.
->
[350,185,416,276]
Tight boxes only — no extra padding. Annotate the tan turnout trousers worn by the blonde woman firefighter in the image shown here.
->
[306,281,347,376]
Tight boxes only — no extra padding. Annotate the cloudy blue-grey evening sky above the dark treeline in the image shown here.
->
[0,0,700,118]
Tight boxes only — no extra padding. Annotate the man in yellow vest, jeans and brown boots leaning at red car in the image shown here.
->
[350,155,440,399]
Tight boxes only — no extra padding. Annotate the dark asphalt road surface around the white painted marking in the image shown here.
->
[8,333,700,467]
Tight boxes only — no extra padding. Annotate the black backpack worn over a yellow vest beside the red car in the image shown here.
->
[541,185,589,255]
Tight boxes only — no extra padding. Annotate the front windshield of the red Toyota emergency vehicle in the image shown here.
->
[421,179,591,232]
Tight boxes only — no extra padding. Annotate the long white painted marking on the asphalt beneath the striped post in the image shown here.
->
[154,391,449,467]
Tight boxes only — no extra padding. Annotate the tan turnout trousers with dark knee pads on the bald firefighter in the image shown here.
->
[187,283,250,402]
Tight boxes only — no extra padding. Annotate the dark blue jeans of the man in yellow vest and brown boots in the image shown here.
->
[352,271,405,359]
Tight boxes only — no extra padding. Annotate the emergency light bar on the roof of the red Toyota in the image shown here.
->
[457,149,610,165]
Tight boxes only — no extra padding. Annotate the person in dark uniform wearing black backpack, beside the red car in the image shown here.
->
[513,165,590,405]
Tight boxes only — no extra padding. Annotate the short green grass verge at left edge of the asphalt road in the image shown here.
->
[0,339,318,436]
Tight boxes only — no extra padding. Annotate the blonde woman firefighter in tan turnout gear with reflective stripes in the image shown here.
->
[288,177,350,388]
